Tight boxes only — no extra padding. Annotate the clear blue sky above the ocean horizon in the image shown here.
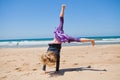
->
[0,0,120,40]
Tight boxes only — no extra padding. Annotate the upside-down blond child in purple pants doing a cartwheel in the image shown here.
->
[41,4,95,73]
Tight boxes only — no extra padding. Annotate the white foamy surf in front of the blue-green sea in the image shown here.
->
[0,38,120,48]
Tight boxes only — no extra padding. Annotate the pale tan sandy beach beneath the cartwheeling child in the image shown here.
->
[0,44,120,80]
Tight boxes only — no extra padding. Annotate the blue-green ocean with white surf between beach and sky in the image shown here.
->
[0,36,120,48]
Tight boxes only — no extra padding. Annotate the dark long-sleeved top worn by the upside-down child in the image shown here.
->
[43,44,61,71]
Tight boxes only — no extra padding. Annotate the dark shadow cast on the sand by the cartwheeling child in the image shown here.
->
[48,66,107,77]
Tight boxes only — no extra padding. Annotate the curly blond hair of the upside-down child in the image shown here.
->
[41,51,57,66]
